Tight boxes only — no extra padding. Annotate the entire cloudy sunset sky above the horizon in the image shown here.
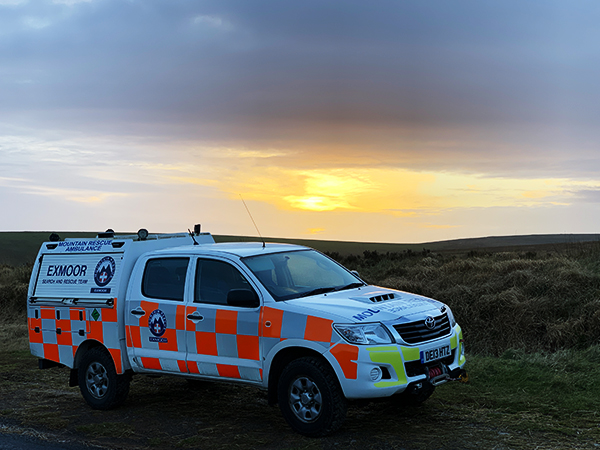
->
[0,0,600,243]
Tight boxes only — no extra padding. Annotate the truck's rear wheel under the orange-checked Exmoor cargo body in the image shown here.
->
[77,347,130,410]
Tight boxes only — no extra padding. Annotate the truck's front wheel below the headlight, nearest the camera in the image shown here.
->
[277,356,347,437]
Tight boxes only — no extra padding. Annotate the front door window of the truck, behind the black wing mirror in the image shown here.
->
[194,259,254,305]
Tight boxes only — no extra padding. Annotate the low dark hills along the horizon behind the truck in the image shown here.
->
[0,231,600,266]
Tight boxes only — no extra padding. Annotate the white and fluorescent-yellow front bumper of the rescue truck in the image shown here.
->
[338,325,466,399]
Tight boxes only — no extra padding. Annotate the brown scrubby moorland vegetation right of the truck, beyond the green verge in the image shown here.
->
[331,251,600,356]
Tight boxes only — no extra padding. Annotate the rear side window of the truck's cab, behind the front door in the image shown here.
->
[142,258,190,302]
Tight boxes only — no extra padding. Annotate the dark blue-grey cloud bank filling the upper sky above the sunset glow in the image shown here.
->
[0,1,600,174]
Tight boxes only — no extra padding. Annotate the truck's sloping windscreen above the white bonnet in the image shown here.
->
[242,250,364,301]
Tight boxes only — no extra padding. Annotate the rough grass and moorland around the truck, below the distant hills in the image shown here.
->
[0,235,600,450]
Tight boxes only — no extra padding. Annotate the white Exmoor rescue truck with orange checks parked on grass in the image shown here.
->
[27,227,465,436]
